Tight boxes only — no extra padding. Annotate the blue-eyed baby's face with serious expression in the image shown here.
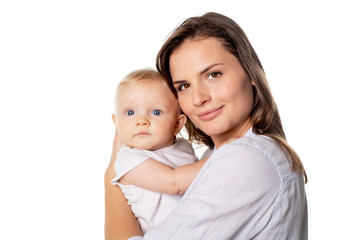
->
[116,80,180,150]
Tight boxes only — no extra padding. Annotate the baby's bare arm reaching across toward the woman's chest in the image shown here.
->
[119,152,207,194]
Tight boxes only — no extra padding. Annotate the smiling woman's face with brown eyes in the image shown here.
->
[170,38,253,147]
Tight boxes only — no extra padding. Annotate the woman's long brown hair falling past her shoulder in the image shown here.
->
[156,12,307,181]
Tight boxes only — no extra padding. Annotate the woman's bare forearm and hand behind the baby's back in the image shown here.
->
[104,126,143,240]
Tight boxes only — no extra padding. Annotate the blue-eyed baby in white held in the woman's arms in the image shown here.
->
[112,69,205,233]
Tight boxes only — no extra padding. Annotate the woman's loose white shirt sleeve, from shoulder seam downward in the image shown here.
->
[144,143,280,239]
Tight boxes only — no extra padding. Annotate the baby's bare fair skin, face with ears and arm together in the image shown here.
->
[113,79,205,194]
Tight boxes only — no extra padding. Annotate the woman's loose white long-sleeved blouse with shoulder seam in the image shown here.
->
[130,129,308,240]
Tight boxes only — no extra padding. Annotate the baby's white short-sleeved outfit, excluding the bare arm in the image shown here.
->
[112,138,198,233]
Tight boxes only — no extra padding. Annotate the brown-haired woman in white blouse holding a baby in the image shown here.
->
[105,13,307,239]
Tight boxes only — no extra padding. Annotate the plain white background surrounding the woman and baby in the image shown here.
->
[0,0,360,239]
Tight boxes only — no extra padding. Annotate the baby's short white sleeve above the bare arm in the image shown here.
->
[111,145,151,184]
